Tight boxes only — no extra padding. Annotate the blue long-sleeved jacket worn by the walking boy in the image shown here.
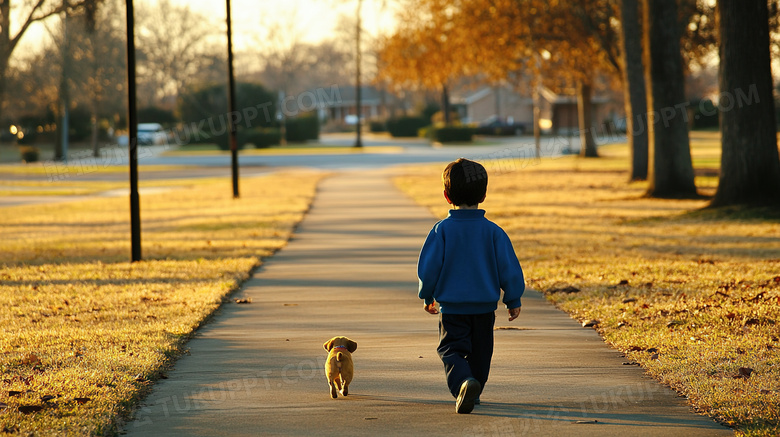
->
[417,209,525,314]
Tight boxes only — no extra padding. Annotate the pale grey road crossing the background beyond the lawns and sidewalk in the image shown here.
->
[0,134,620,207]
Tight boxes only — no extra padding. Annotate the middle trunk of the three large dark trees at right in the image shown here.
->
[643,0,698,198]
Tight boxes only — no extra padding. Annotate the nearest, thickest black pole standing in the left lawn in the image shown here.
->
[125,0,141,262]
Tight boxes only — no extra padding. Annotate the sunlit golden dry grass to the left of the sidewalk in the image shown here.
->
[0,172,321,435]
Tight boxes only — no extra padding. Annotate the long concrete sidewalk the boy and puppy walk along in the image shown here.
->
[125,172,733,437]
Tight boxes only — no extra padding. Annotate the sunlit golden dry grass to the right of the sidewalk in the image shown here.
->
[396,139,780,435]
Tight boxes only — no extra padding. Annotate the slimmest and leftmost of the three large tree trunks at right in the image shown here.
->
[620,0,647,181]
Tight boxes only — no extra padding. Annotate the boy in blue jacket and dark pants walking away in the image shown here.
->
[417,158,525,414]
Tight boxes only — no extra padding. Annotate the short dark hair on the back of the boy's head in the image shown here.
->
[441,158,487,205]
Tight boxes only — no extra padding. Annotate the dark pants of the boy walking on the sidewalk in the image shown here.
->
[437,312,496,397]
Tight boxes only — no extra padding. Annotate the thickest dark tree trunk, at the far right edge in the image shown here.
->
[711,0,780,206]
